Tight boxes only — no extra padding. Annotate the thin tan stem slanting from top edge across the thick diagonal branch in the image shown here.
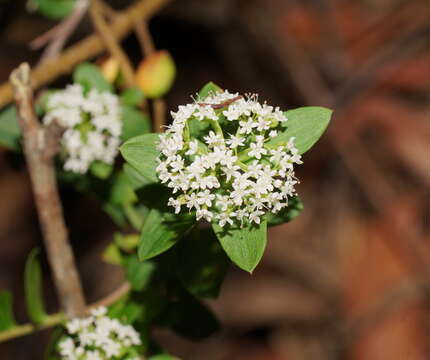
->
[90,0,135,87]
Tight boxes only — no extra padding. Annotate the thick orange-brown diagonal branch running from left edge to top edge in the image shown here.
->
[0,0,170,108]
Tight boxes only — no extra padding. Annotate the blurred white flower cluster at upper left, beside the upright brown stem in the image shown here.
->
[43,84,122,174]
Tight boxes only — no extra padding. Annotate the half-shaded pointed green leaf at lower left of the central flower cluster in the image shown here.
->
[139,209,196,261]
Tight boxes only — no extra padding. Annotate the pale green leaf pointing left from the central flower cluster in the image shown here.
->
[120,134,160,185]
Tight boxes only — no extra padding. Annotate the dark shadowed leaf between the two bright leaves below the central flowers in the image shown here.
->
[175,228,230,298]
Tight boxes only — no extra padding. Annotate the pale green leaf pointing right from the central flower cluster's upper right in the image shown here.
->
[269,106,333,154]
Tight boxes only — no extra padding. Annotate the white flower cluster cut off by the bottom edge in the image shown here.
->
[58,307,141,360]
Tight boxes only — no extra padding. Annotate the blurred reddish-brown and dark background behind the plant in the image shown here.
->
[0,0,430,360]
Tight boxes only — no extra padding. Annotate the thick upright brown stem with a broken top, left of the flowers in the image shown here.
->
[10,63,85,317]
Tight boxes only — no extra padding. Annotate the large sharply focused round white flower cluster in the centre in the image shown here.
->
[157,91,302,227]
